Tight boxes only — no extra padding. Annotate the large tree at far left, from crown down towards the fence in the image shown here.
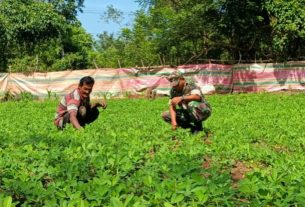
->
[0,0,66,69]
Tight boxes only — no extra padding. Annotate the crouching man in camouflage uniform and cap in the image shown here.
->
[162,71,212,133]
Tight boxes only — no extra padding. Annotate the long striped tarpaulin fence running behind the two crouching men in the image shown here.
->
[0,62,305,97]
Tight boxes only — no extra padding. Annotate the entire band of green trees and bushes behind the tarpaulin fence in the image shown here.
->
[0,0,305,72]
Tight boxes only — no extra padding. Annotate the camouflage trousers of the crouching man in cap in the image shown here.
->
[162,101,212,128]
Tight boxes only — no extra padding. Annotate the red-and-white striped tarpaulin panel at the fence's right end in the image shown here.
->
[233,62,305,92]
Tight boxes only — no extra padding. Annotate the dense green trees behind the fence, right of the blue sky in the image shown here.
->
[97,0,305,66]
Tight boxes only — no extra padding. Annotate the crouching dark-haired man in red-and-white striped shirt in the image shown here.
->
[54,76,107,130]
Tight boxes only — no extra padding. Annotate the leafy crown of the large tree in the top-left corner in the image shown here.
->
[0,0,65,47]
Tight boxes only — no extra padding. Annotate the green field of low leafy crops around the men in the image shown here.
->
[0,93,305,207]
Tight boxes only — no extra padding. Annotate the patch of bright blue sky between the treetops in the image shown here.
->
[78,0,139,38]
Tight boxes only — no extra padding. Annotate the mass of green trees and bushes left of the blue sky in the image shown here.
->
[0,0,93,72]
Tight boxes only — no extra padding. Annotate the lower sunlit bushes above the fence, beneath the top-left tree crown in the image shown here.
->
[9,25,93,72]
